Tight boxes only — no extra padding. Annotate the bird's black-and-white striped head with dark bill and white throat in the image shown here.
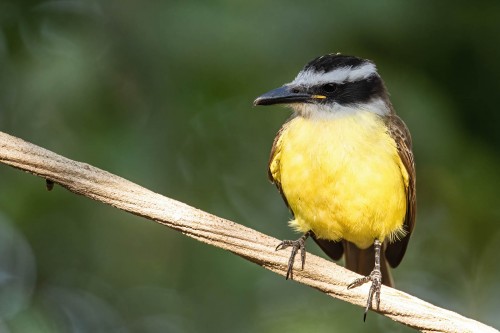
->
[254,54,393,117]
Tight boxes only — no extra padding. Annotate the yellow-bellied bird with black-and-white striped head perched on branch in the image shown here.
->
[254,53,416,320]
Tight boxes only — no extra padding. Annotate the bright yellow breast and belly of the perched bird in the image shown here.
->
[270,111,408,248]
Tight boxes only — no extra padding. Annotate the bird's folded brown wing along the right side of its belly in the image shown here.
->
[385,114,417,267]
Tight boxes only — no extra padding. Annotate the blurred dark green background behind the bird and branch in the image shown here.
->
[0,0,500,333]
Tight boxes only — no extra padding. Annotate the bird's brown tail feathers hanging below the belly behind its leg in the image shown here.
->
[342,241,394,287]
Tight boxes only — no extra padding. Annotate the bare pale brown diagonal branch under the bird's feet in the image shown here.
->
[0,132,498,332]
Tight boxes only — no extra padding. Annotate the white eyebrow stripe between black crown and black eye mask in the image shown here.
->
[290,63,377,87]
